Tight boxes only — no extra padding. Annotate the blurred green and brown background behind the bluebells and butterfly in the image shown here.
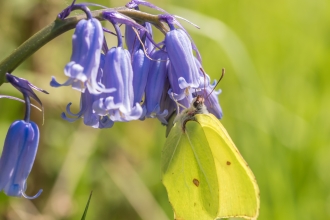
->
[0,0,330,220]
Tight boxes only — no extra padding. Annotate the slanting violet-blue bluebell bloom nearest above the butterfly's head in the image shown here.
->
[165,29,200,89]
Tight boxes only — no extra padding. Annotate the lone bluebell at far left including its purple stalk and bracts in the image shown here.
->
[0,74,48,199]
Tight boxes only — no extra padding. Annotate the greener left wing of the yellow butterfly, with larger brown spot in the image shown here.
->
[161,122,219,220]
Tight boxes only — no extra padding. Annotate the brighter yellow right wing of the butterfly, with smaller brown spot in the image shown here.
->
[195,114,260,219]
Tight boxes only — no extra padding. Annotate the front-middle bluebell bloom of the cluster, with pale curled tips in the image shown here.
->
[93,46,143,121]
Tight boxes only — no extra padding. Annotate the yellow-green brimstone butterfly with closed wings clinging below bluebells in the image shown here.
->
[161,96,260,220]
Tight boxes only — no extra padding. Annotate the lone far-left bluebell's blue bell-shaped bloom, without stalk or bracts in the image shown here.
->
[0,120,42,199]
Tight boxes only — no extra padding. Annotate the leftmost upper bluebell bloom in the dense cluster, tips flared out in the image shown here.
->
[50,18,114,94]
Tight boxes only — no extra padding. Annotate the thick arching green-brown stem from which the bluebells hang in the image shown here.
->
[0,7,167,86]
